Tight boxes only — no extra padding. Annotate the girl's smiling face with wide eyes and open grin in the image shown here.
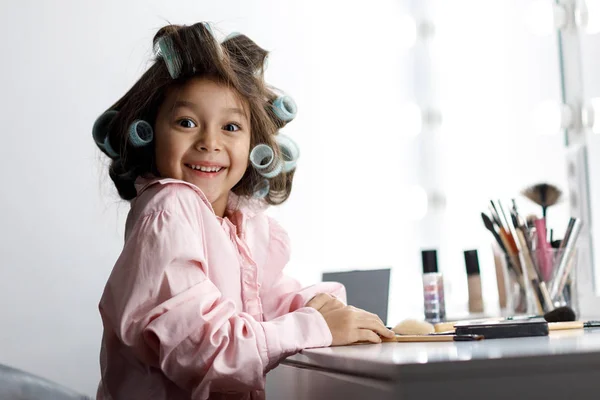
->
[154,78,250,217]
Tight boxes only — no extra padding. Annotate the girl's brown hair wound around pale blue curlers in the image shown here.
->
[103,23,294,205]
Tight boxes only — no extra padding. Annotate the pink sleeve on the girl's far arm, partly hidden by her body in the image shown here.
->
[261,218,346,322]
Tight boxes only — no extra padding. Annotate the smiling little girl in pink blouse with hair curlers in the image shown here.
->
[93,23,393,400]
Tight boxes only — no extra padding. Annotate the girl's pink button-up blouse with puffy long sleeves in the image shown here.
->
[97,179,346,400]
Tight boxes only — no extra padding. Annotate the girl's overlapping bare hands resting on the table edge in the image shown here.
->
[306,294,395,346]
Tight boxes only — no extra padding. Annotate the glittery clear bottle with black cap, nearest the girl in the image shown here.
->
[421,250,446,323]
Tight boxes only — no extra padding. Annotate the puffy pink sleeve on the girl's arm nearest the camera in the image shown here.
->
[100,191,331,399]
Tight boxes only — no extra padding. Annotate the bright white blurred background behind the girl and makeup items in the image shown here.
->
[0,0,600,395]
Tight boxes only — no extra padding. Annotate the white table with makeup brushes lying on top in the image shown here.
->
[267,329,600,400]
